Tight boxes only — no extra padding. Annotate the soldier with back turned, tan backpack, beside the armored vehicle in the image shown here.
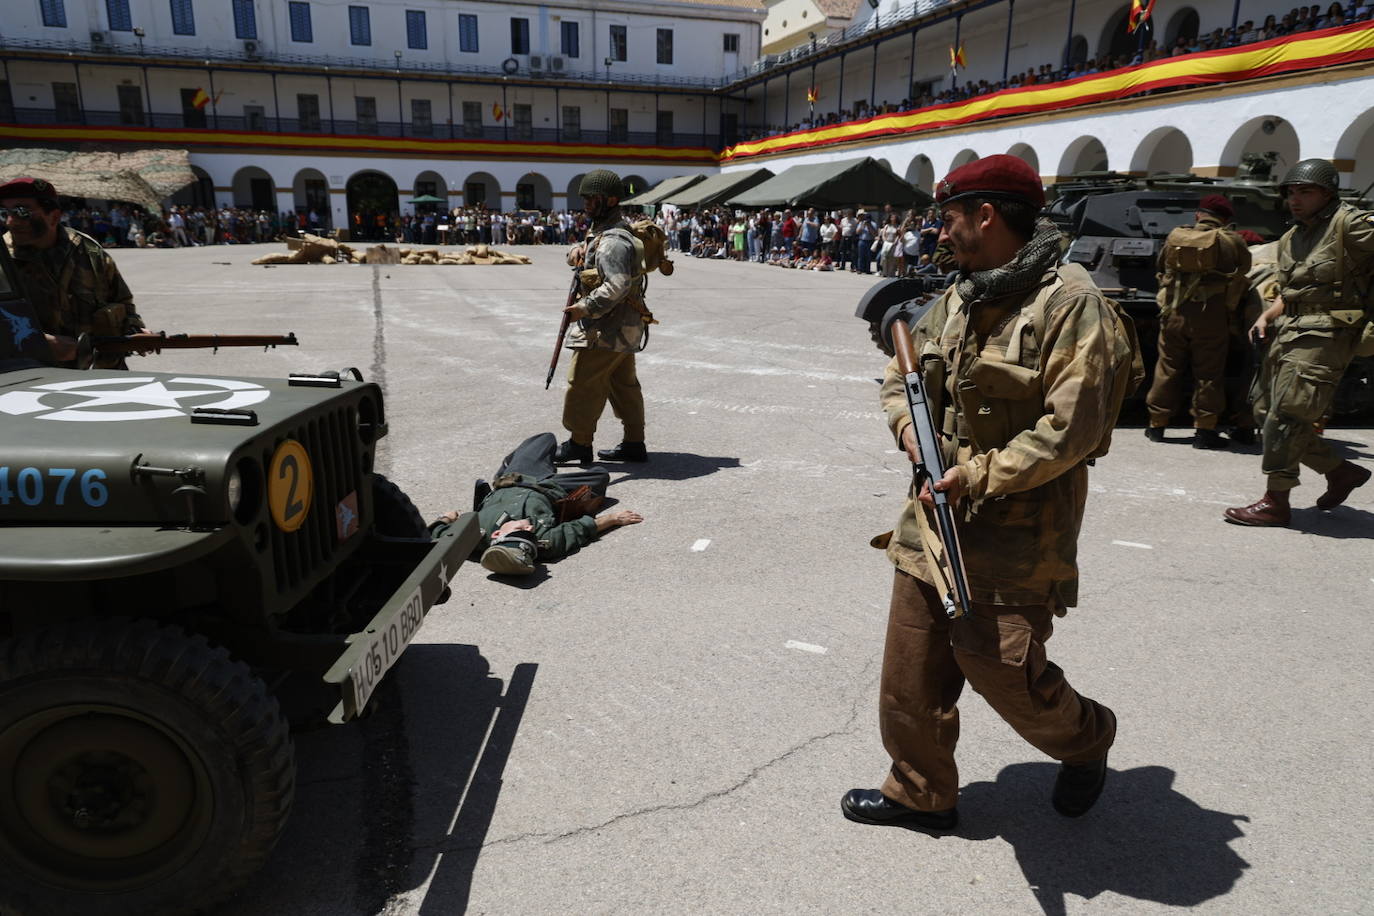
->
[1145,194,1250,449]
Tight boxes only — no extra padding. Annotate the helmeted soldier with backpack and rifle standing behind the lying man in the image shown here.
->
[554,169,654,466]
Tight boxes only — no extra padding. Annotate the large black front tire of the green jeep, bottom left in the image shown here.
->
[0,619,295,916]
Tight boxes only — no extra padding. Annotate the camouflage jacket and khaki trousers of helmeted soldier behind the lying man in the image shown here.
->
[563,210,649,445]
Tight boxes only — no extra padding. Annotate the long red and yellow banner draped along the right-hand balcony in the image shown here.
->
[720,22,1374,162]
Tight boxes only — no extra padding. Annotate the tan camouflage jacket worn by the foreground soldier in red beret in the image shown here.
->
[881,264,1114,612]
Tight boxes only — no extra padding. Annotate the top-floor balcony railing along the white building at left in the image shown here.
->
[0,36,743,89]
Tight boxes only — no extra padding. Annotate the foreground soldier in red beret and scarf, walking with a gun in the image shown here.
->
[841,155,1143,832]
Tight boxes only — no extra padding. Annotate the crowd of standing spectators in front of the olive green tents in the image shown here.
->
[657,205,944,277]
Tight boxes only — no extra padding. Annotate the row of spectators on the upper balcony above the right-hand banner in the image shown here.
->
[746,0,1374,140]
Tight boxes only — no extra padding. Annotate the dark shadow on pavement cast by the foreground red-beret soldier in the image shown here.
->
[959,764,1249,916]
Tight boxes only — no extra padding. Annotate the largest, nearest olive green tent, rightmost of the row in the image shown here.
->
[728,157,932,210]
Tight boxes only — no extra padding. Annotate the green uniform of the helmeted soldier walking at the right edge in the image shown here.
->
[1254,201,1374,492]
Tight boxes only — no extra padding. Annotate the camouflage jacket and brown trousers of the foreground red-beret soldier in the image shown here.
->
[875,248,1120,810]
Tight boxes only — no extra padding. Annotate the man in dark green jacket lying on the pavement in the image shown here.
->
[430,433,644,575]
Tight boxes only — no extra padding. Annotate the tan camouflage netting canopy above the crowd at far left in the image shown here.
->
[0,150,195,210]
